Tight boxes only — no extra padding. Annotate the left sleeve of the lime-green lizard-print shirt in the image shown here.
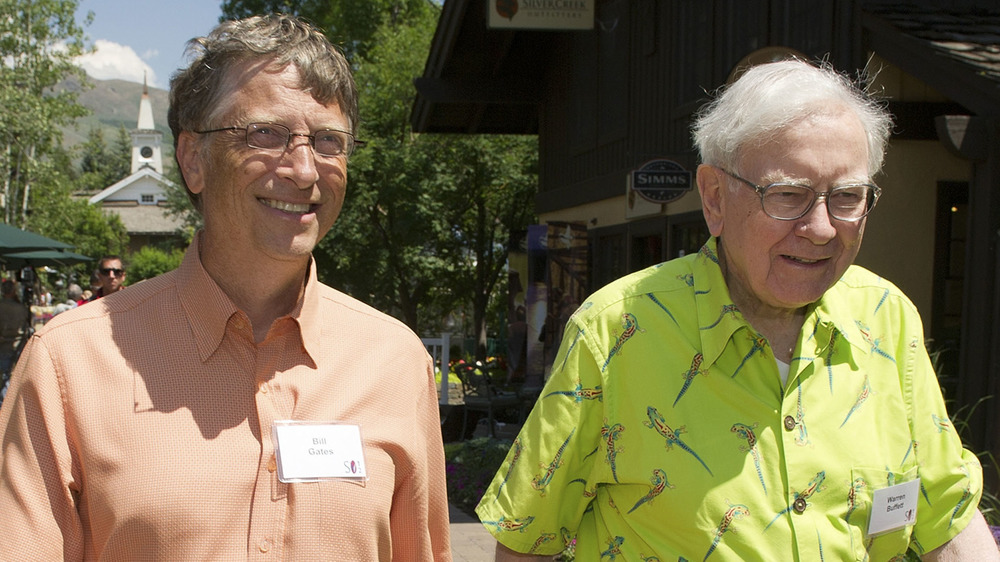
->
[476,319,606,555]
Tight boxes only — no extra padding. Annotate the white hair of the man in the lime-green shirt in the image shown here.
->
[691,60,892,176]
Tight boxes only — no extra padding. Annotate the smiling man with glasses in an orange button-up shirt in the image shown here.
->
[0,16,450,561]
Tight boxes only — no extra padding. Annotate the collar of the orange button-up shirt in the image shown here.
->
[177,232,321,361]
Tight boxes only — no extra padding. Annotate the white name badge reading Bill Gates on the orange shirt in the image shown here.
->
[271,420,368,482]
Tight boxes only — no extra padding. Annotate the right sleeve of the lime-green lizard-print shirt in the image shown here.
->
[899,309,983,553]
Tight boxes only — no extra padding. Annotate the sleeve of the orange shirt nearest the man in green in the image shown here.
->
[389,356,451,562]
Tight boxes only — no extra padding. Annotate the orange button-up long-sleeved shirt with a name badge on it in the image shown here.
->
[0,238,451,561]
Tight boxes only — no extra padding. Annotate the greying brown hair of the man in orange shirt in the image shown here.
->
[167,14,358,207]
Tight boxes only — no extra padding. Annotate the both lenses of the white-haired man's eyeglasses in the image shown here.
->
[763,184,875,220]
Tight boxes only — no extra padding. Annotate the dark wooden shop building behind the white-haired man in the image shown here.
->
[411,0,1000,458]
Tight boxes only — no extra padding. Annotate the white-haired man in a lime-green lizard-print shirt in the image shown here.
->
[477,61,1000,561]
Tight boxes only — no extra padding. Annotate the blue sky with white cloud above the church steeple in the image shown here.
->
[76,0,221,89]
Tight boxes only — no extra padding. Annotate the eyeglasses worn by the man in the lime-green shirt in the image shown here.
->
[719,168,882,222]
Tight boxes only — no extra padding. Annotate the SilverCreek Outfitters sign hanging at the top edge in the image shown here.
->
[486,0,596,29]
